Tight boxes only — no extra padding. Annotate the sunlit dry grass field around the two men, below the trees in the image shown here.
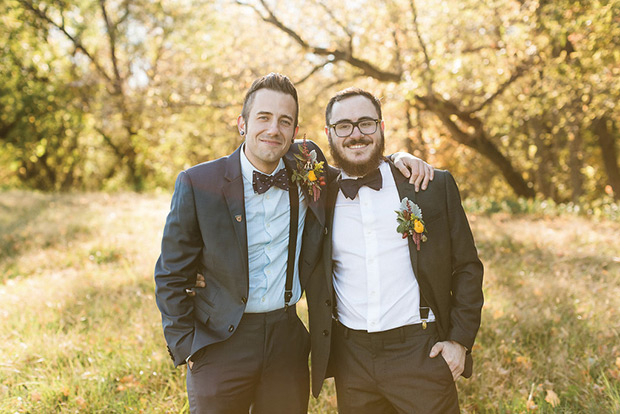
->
[0,191,620,414]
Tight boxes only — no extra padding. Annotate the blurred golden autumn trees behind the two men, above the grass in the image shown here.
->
[0,0,620,203]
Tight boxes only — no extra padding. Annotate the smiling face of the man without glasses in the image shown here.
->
[237,89,298,174]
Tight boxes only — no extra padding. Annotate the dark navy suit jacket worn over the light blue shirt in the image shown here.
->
[155,141,327,366]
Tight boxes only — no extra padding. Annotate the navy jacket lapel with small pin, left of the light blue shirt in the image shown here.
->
[222,146,249,280]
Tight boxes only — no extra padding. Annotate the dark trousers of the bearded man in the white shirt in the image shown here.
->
[333,323,460,414]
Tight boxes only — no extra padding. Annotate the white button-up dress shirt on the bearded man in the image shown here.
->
[332,162,435,332]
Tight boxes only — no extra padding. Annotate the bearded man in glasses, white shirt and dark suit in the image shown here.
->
[306,89,483,414]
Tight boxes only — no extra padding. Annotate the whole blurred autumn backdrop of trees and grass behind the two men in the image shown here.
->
[0,0,620,414]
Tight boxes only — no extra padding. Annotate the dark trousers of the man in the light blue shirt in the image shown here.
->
[187,306,310,414]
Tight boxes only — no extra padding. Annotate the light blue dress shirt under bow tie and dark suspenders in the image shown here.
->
[241,146,308,313]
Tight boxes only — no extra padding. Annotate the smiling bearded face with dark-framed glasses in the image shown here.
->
[325,95,384,177]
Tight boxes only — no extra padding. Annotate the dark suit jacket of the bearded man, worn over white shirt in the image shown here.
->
[306,162,483,396]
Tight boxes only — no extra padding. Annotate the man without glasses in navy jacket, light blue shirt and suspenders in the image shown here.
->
[155,74,434,414]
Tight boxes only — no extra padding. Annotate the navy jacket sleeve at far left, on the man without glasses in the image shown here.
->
[155,172,203,366]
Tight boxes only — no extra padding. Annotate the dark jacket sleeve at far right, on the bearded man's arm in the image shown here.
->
[445,173,484,351]
